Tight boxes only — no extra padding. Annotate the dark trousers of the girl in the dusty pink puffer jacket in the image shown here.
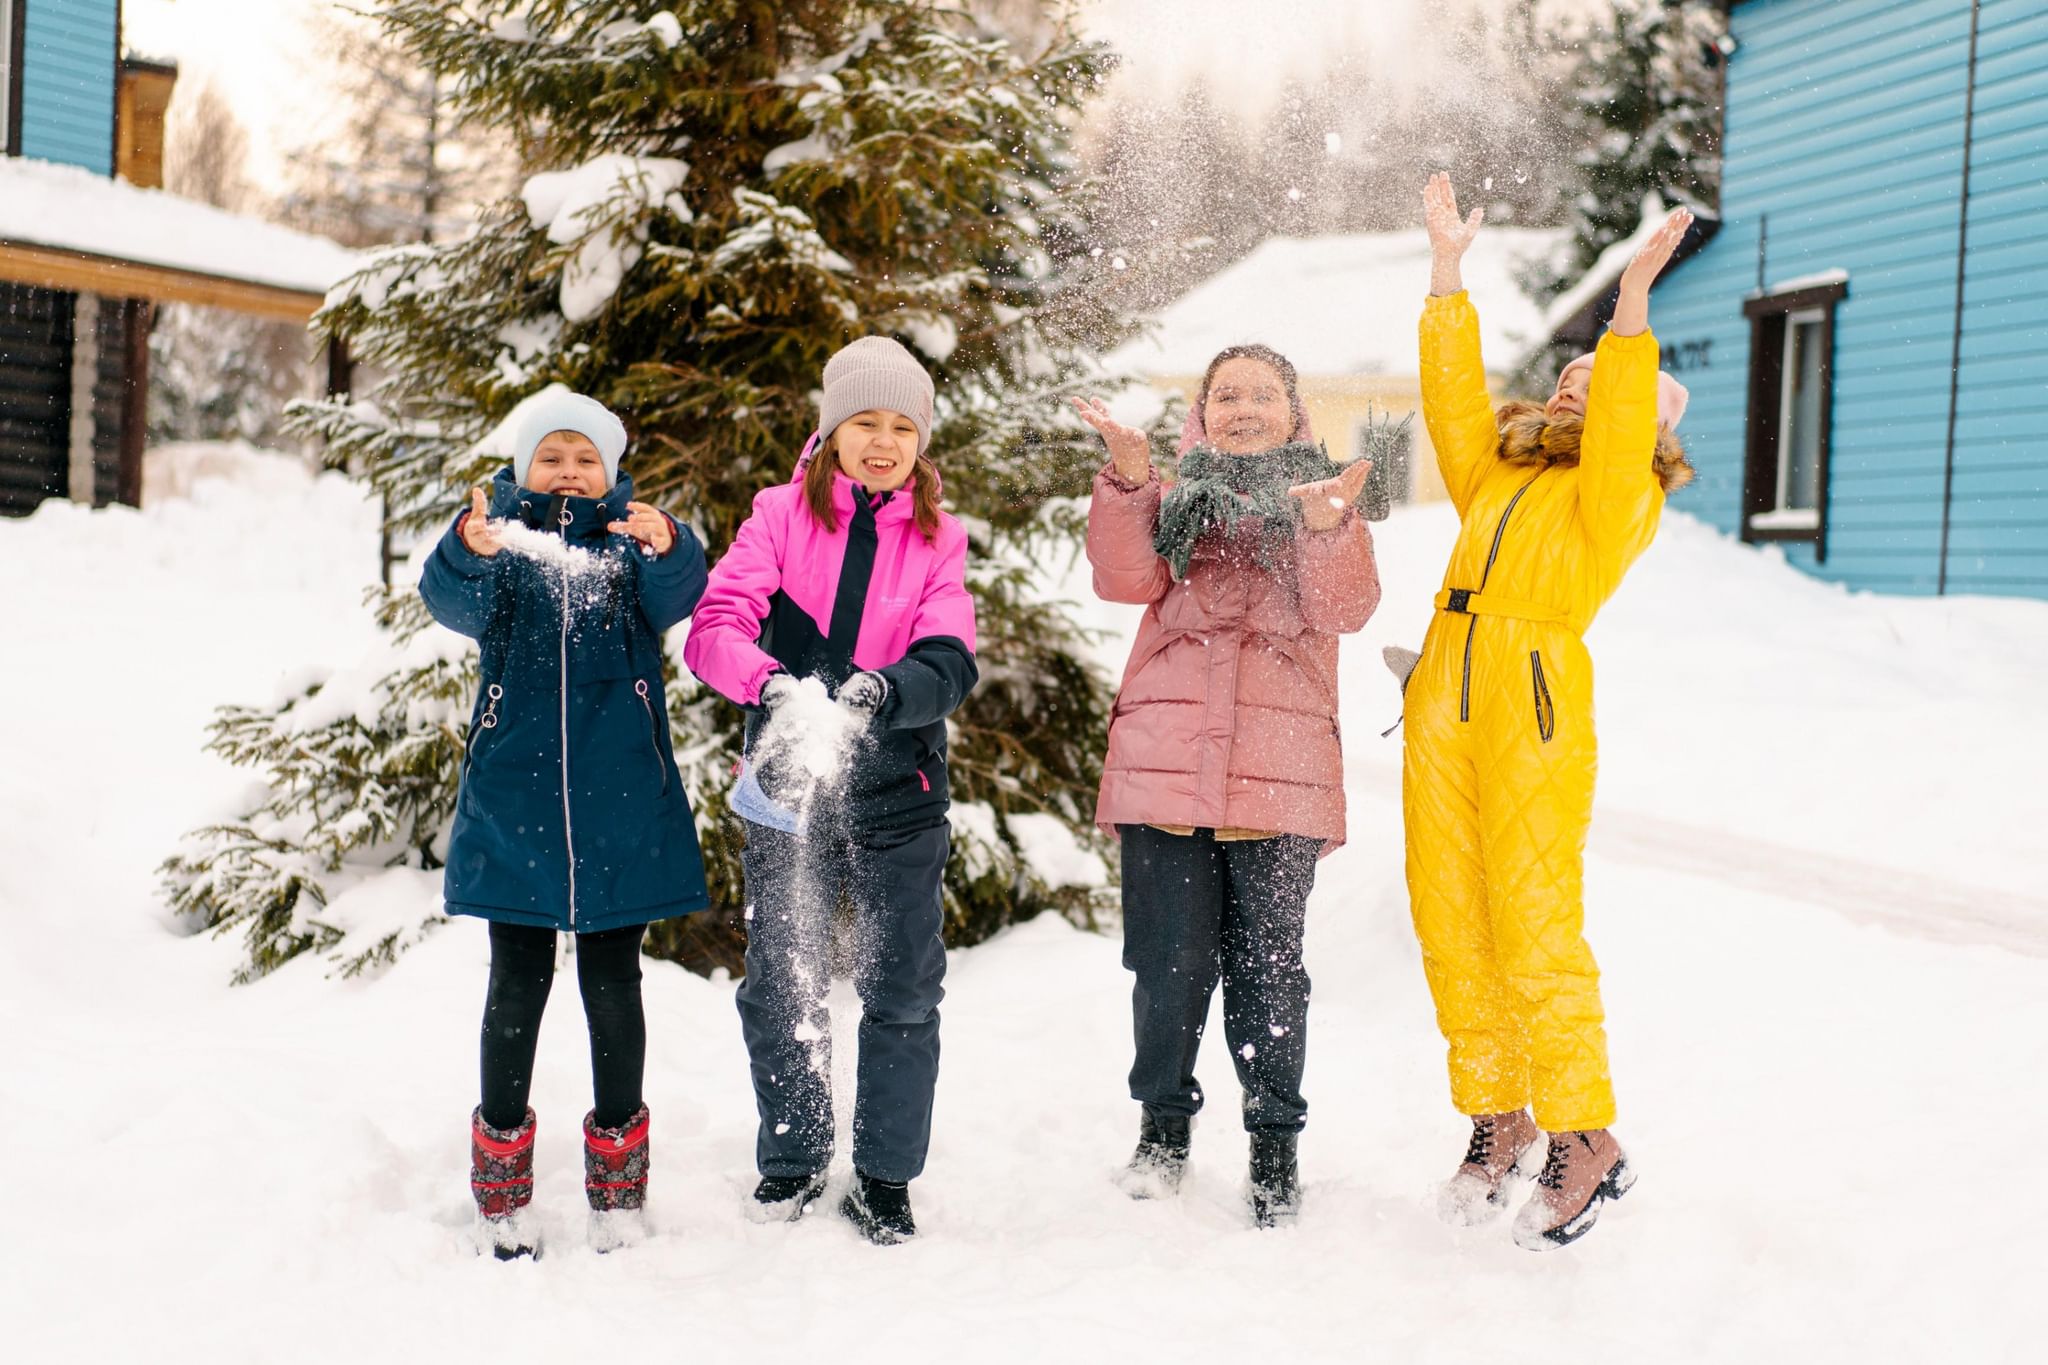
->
[1116,825,1323,1132]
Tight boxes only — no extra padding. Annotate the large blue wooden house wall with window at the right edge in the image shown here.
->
[1548,0,2048,598]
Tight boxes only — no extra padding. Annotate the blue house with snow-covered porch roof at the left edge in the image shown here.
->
[0,0,352,514]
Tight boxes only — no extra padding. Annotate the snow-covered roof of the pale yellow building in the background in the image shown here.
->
[1110,227,1565,377]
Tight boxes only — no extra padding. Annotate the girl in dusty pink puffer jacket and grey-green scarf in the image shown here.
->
[1081,346,1380,1226]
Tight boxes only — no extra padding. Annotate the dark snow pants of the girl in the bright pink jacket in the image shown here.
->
[739,823,946,1181]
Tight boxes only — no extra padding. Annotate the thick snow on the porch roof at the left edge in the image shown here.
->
[0,156,356,295]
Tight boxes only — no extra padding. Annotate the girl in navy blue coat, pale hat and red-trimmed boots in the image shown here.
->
[420,391,709,1259]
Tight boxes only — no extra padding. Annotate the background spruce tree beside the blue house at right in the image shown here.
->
[1530,0,1729,297]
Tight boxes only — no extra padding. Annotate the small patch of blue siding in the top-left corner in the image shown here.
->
[20,0,119,176]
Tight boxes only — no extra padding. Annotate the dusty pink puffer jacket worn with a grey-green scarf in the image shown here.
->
[1087,467,1380,853]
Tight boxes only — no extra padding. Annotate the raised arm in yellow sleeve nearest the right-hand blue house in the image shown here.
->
[1579,209,1692,575]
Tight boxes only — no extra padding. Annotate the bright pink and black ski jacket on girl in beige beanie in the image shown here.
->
[682,436,979,829]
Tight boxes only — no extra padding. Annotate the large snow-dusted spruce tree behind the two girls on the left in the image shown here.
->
[166,0,1126,972]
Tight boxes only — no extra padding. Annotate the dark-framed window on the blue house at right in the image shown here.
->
[1743,278,1849,559]
